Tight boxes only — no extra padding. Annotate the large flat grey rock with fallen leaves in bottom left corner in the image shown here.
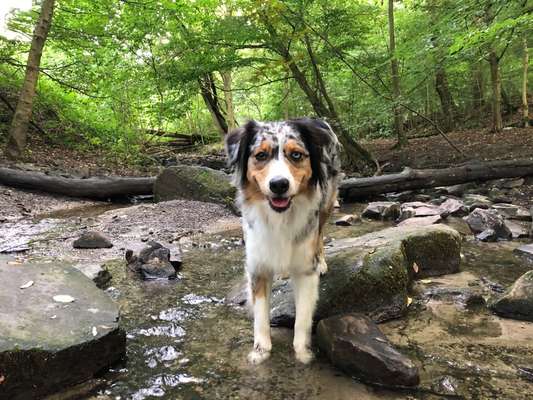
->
[0,261,126,400]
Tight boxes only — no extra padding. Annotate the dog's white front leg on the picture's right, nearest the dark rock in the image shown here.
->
[291,271,319,364]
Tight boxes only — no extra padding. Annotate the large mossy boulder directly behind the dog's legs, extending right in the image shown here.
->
[271,224,461,326]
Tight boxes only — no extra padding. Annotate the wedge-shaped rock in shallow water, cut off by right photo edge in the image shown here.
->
[490,271,533,321]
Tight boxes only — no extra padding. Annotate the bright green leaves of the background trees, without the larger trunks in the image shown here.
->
[0,0,533,156]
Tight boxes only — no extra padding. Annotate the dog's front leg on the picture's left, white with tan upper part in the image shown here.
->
[248,274,272,364]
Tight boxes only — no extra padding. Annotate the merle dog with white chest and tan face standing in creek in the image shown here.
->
[225,118,341,364]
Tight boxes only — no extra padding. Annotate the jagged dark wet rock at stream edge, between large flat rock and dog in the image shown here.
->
[126,241,181,279]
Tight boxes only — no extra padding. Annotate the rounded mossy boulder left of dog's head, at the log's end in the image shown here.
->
[154,165,235,207]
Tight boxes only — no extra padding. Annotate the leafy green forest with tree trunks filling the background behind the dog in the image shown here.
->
[0,0,533,170]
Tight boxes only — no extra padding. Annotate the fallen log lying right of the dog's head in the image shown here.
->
[339,159,533,201]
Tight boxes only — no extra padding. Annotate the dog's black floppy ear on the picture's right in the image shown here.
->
[289,118,340,186]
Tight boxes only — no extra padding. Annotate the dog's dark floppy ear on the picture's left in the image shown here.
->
[225,121,258,184]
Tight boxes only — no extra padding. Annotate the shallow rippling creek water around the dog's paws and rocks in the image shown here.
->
[3,205,533,400]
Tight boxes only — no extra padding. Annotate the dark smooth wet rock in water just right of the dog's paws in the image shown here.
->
[317,314,420,387]
